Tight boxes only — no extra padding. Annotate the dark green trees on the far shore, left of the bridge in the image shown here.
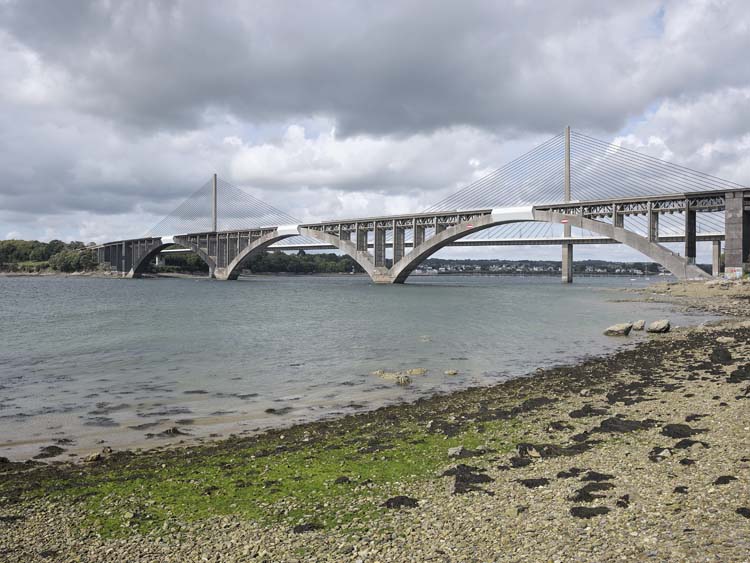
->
[0,240,97,272]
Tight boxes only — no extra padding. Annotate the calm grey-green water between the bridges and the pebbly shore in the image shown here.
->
[0,276,703,459]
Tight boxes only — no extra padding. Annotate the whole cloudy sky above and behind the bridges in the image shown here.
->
[0,0,750,259]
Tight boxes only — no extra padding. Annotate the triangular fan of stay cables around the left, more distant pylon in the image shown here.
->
[146,178,299,237]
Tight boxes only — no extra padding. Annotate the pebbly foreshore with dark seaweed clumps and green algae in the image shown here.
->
[0,283,750,563]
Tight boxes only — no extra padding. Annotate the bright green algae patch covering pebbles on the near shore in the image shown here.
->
[0,410,524,537]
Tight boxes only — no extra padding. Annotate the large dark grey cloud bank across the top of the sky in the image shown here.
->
[0,0,750,135]
